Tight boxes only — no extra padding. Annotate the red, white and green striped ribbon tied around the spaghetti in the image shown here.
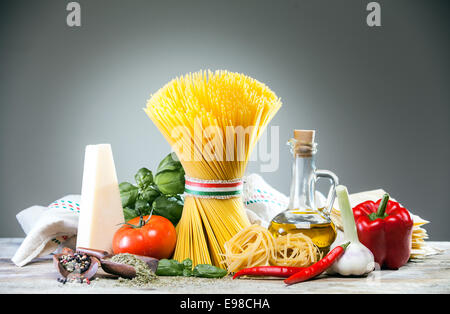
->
[184,176,243,199]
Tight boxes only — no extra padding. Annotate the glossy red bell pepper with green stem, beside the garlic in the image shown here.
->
[353,194,413,269]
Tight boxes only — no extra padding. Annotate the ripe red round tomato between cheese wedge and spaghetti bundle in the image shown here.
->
[113,215,177,259]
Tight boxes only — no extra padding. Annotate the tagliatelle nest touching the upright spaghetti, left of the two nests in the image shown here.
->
[225,225,275,273]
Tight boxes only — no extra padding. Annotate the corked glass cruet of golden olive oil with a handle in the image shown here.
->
[269,130,338,254]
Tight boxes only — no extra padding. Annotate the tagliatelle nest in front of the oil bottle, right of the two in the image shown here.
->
[270,233,322,267]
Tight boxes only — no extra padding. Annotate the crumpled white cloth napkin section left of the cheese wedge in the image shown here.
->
[11,195,80,266]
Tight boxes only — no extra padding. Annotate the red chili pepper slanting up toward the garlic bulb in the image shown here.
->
[284,242,350,285]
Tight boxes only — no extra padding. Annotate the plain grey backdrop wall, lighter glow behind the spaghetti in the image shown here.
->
[0,0,450,240]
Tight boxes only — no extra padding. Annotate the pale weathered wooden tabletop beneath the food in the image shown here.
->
[0,238,450,294]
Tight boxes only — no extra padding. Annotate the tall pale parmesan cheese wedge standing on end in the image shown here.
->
[77,144,125,253]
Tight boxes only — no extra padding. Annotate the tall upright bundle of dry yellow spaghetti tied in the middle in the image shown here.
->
[145,71,281,267]
